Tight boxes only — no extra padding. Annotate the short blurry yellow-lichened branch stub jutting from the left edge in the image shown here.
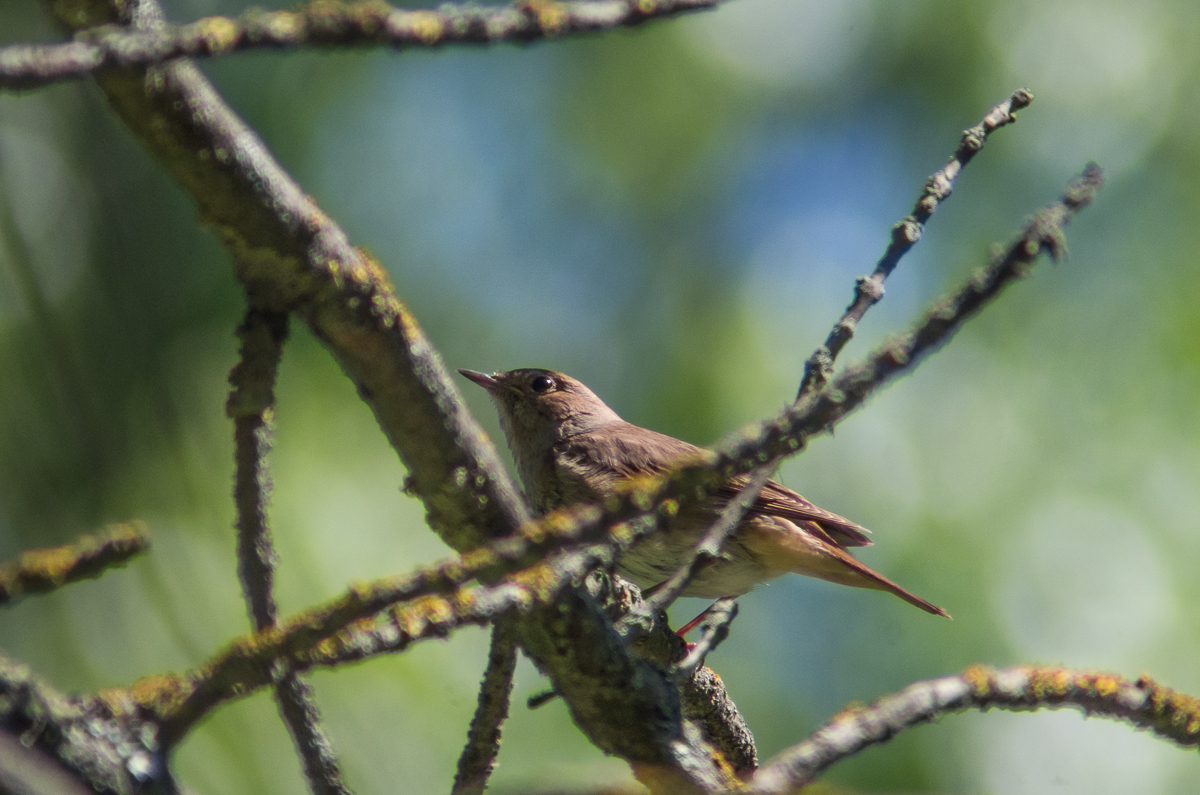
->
[0,521,150,605]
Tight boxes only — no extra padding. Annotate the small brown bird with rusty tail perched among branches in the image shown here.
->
[458,369,949,618]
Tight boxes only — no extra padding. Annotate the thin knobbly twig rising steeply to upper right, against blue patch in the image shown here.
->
[796,89,1033,401]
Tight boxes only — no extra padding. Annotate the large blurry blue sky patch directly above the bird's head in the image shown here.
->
[318,47,638,353]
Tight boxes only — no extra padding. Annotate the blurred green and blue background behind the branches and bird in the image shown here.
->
[0,0,1200,795]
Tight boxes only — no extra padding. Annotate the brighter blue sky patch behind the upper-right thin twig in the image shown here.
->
[720,112,941,343]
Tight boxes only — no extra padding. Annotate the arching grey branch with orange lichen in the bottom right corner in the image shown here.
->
[745,665,1200,795]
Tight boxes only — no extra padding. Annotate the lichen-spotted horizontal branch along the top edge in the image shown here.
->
[0,0,720,89]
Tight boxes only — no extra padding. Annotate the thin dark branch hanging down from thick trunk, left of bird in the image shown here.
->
[226,307,350,795]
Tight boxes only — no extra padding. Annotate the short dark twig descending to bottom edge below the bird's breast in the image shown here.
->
[450,618,517,795]
